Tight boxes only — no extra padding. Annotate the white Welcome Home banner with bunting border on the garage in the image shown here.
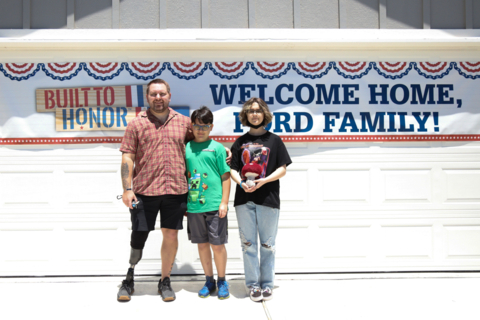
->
[0,61,480,145]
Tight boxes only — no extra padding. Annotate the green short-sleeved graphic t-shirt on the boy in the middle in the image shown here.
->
[185,140,230,213]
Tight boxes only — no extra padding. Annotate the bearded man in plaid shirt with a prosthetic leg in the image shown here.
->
[117,79,231,301]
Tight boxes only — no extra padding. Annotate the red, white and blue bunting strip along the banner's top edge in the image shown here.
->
[0,61,480,81]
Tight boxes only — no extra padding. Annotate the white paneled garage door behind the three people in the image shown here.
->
[0,142,480,276]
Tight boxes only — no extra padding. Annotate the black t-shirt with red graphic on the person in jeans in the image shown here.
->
[230,131,292,209]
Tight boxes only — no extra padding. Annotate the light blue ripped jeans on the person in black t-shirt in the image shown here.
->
[235,201,280,289]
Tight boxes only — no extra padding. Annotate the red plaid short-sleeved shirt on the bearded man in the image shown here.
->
[120,108,194,196]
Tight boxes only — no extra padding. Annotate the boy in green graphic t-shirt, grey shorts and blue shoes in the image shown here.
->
[185,106,230,299]
